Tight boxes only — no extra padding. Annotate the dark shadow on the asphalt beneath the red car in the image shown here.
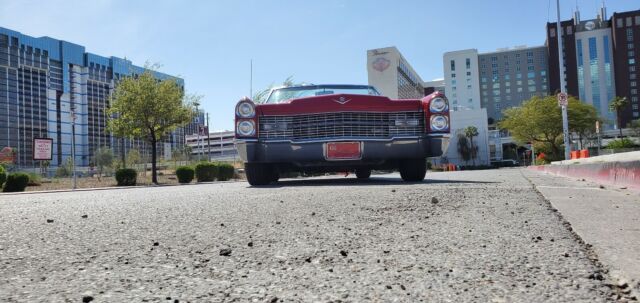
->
[248,176,499,188]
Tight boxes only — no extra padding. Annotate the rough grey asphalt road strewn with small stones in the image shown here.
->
[0,169,629,302]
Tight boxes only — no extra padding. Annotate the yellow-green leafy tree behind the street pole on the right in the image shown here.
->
[499,96,598,159]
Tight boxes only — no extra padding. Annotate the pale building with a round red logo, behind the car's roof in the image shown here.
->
[367,46,424,99]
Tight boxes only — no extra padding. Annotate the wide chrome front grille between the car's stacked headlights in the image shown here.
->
[259,112,424,141]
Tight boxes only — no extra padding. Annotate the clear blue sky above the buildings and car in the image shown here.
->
[0,0,640,129]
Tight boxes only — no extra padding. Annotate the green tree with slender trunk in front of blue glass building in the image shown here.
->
[107,66,200,184]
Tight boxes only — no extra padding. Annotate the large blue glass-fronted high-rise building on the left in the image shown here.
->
[0,27,184,167]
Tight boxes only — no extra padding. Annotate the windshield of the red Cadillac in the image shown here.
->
[265,85,380,103]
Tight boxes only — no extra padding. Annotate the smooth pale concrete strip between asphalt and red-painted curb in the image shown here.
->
[522,169,640,298]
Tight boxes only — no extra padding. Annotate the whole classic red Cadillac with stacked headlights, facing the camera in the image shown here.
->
[235,85,449,185]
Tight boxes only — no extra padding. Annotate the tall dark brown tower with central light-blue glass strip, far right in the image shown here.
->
[547,7,640,129]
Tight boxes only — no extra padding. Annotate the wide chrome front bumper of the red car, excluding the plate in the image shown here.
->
[236,135,449,167]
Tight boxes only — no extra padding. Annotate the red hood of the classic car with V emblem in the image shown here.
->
[256,94,422,116]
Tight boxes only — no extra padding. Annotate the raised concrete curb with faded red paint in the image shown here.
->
[530,152,640,191]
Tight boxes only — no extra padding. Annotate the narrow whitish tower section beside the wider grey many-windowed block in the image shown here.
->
[443,49,480,111]
